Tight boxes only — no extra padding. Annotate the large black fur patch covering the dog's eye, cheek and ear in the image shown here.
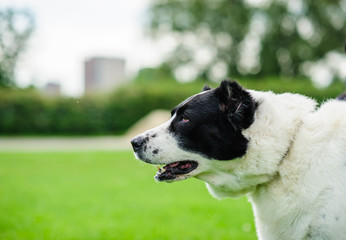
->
[169,81,257,160]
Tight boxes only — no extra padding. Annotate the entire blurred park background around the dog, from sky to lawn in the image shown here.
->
[0,0,346,239]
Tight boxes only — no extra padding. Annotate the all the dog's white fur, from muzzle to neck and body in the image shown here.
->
[137,91,346,240]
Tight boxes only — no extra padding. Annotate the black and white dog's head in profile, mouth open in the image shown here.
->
[131,81,257,181]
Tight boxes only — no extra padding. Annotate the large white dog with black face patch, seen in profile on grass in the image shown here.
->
[131,80,346,240]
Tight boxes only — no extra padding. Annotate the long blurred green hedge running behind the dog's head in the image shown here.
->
[0,79,343,135]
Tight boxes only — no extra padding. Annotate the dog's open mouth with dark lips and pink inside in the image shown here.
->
[155,161,198,182]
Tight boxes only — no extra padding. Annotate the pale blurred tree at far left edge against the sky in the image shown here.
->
[0,9,35,87]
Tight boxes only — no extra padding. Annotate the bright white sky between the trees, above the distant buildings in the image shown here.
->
[0,0,165,96]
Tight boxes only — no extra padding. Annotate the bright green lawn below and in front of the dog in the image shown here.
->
[0,152,256,240]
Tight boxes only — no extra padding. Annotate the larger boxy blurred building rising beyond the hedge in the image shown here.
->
[84,58,125,93]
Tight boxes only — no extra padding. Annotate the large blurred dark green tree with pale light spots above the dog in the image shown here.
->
[148,0,346,80]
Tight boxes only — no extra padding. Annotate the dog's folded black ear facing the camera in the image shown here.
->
[216,80,257,130]
